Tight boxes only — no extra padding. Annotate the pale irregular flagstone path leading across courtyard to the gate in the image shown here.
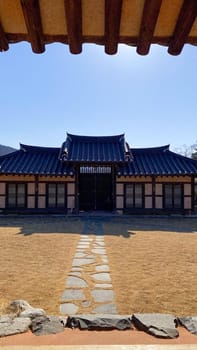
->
[60,220,117,315]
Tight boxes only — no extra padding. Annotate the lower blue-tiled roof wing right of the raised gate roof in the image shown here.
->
[118,145,197,175]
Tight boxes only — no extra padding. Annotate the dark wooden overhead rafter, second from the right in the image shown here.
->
[137,0,162,55]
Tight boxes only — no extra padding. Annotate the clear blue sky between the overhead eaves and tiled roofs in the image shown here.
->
[0,43,197,149]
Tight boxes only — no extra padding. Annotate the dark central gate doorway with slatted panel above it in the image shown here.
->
[79,166,113,211]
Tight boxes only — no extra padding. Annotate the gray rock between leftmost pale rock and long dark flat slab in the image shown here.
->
[31,316,64,335]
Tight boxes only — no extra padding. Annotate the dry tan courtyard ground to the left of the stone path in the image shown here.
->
[0,218,80,314]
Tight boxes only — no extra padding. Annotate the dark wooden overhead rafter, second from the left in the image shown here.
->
[21,0,45,53]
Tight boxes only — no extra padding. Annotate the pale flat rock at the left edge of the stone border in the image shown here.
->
[0,316,31,337]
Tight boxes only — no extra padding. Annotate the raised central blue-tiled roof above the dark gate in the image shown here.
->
[60,134,131,163]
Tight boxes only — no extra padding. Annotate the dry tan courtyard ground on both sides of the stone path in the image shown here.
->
[0,216,197,316]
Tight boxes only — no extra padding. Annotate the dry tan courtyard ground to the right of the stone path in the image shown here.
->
[105,218,197,315]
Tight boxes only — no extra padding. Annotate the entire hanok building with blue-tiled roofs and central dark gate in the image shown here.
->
[0,134,197,214]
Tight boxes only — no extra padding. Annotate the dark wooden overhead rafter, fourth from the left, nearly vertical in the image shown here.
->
[105,0,122,55]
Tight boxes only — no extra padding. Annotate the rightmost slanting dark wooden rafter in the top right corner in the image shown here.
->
[168,0,197,55]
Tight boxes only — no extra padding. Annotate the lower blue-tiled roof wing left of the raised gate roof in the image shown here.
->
[0,145,73,176]
